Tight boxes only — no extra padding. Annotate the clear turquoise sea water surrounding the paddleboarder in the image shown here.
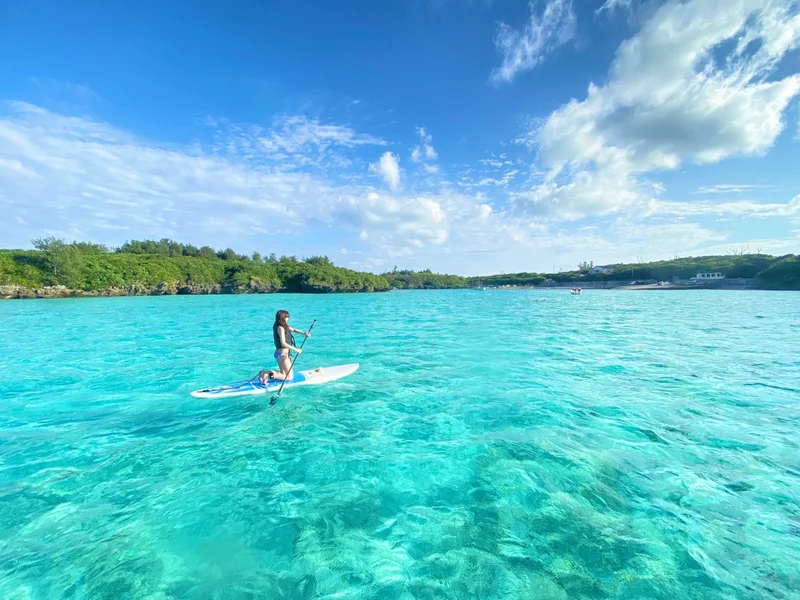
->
[0,291,800,600]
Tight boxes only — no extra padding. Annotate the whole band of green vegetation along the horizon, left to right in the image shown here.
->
[0,238,800,293]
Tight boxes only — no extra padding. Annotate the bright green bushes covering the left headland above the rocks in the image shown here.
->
[0,238,391,292]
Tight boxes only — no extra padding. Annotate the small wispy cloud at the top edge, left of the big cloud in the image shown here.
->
[491,0,575,84]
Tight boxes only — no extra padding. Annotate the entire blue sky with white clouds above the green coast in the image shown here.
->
[0,0,800,274]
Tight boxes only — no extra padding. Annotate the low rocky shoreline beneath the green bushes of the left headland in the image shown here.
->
[0,281,382,300]
